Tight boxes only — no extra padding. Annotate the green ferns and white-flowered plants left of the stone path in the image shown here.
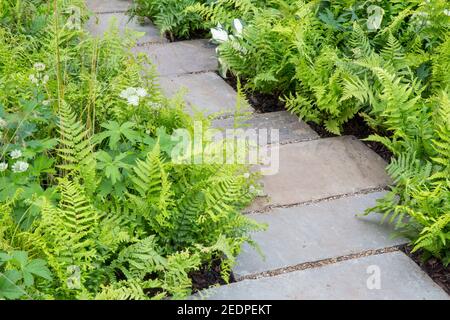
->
[0,0,259,299]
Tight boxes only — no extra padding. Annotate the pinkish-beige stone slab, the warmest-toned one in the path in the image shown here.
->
[247,136,390,211]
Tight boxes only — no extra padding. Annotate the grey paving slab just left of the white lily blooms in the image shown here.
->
[133,40,218,76]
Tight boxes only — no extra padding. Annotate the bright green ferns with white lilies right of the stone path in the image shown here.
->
[132,0,450,265]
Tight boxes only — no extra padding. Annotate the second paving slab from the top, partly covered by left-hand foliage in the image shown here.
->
[86,12,167,44]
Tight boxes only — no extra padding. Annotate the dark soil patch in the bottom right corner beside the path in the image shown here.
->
[401,246,450,294]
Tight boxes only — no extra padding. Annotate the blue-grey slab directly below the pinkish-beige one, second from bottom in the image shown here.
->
[233,192,408,278]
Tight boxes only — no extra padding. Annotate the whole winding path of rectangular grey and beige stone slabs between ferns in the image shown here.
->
[87,0,449,299]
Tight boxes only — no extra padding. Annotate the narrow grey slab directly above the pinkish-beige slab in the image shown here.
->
[212,111,319,144]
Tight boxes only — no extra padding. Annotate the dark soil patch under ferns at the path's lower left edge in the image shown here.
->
[189,258,236,293]
